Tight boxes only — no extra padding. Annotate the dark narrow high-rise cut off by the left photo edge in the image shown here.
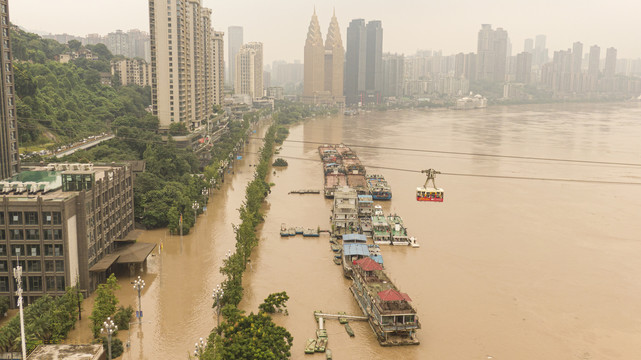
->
[0,0,20,179]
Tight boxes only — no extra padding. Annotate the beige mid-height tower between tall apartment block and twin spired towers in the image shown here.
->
[234,42,263,99]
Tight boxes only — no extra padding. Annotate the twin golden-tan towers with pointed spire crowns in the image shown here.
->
[303,10,345,105]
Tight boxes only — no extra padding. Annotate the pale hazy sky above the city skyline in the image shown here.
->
[9,0,641,64]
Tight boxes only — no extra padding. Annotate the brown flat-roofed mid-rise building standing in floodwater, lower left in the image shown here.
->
[0,164,142,307]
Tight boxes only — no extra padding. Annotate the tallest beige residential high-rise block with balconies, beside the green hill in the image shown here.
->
[149,0,223,130]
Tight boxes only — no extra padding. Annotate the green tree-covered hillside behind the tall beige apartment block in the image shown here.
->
[11,30,151,146]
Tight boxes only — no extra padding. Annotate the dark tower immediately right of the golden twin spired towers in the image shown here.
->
[345,19,367,104]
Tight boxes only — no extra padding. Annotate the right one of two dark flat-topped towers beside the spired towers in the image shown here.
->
[365,20,383,104]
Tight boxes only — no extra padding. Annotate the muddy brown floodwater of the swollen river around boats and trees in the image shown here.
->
[70,104,641,360]
